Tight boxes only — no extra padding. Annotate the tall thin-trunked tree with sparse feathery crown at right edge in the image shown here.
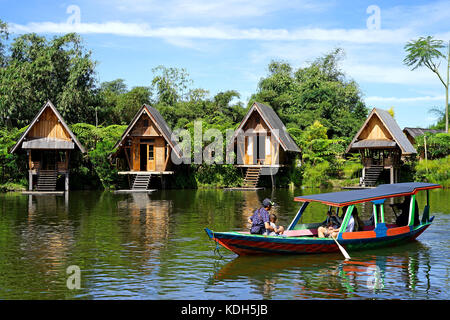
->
[403,36,450,132]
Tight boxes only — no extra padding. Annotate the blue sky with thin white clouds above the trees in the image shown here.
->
[0,0,450,128]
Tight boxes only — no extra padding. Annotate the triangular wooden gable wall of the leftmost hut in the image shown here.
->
[27,108,71,141]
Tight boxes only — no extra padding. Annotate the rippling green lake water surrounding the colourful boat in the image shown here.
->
[0,189,450,300]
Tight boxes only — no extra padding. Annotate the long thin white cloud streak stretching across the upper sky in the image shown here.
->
[9,21,411,43]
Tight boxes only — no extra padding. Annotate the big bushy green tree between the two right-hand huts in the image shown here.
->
[249,49,368,143]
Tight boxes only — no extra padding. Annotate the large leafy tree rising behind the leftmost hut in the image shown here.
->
[0,33,98,126]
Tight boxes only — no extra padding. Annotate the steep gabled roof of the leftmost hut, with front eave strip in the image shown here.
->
[10,100,86,153]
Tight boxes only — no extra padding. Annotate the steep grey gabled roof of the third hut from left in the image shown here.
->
[230,102,301,152]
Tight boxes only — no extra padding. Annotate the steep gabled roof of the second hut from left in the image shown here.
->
[113,104,181,158]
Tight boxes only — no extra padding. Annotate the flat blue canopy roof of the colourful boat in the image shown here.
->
[294,182,441,207]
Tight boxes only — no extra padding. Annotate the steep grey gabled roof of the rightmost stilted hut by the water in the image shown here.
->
[346,108,417,155]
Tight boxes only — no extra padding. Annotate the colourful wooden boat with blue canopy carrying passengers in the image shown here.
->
[205,182,441,255]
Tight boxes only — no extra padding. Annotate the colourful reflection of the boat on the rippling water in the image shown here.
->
[212,242,442,299]
